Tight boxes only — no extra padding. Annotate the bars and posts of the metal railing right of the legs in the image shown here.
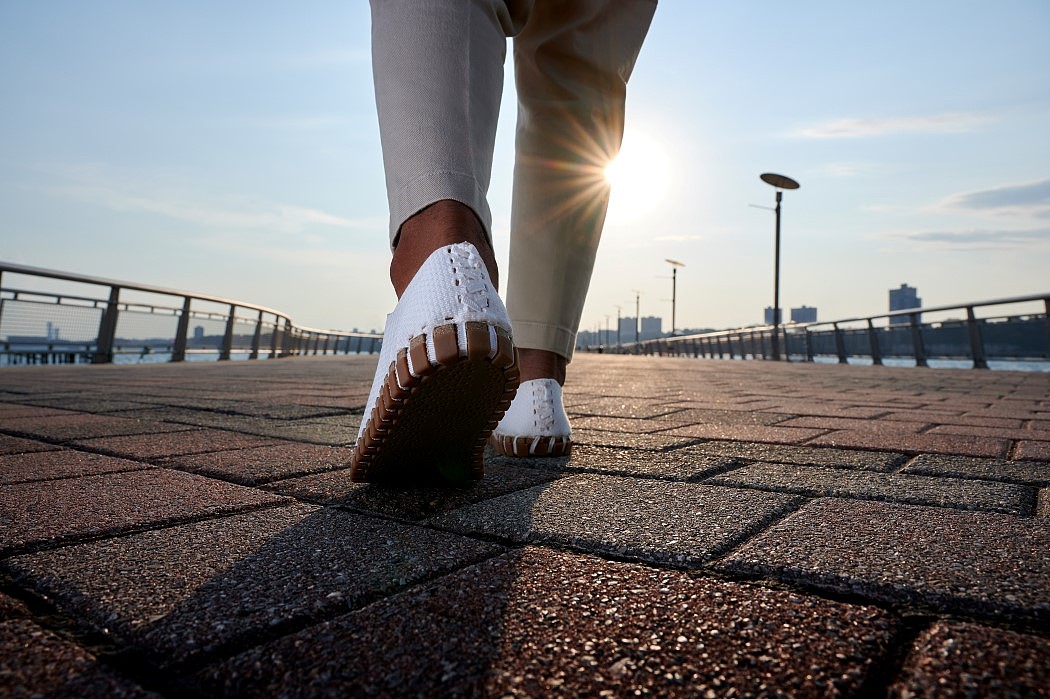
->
[602,293,1050,368]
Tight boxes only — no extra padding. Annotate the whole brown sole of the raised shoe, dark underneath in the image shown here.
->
[350,322,519,486]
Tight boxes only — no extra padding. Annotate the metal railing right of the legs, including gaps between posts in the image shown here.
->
[600,294,1050,368]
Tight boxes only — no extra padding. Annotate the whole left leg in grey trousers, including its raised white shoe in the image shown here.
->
[351,0,527,483]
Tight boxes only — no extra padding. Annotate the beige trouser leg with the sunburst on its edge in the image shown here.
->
[507,0,656,358]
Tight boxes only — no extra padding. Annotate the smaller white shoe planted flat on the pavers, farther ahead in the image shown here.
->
[489,379,572,457]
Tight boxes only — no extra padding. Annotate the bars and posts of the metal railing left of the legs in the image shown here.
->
[0,261,382,363]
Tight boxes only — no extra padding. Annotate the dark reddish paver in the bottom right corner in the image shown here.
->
[890,621,1050,699]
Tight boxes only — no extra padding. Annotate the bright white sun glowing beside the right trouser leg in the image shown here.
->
[605,127,669,221]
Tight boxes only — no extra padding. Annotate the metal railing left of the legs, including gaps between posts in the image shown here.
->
[0,262,382,364]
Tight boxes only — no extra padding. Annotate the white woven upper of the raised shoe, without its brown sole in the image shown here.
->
[357,242,510,439]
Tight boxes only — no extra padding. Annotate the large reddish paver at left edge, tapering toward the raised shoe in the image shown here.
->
[0,469,281,552]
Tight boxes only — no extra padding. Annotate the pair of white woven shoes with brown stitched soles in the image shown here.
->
[351,242,571,484]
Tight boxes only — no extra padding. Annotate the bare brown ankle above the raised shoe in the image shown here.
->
[391,199,500,298]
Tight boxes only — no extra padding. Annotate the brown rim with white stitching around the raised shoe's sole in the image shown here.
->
[350,321,519,483]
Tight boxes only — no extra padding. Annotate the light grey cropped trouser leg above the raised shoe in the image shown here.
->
[372,0,531,248]
